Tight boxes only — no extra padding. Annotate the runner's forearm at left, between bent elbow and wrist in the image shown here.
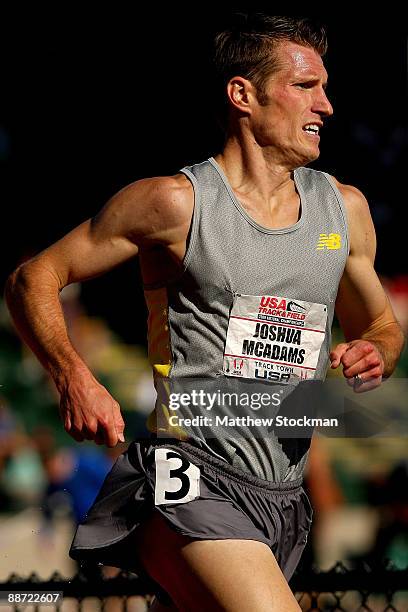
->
[5,260,86,387]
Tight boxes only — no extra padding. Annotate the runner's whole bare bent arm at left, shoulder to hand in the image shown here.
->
[5,177,190,446]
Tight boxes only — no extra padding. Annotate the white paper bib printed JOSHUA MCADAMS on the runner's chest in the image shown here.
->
[223,294,327,383]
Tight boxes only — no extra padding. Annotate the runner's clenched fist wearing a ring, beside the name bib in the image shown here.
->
[330,340,384,393]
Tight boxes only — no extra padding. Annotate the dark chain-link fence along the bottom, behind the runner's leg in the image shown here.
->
[0,562,408,612]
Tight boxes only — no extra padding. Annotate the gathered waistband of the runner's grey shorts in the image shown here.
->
[149,438,303,492]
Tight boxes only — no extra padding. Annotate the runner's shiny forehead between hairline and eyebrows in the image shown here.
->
[276,41,327,79]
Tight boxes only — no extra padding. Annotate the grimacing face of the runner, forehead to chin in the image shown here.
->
[251,41,333,168]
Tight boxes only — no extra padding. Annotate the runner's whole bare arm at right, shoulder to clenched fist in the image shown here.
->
[330,181,404,393]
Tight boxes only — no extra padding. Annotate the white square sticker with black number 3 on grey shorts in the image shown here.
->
[154,448,200,506]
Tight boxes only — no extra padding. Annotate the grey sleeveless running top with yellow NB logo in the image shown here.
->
[145,158,349,482]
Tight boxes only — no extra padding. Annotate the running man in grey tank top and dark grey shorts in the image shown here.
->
[7,14,403,612]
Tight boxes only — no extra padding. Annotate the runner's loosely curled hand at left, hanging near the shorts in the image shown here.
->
[57,370,125,447]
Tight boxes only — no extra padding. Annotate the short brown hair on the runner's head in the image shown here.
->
[214,13,327,115]
